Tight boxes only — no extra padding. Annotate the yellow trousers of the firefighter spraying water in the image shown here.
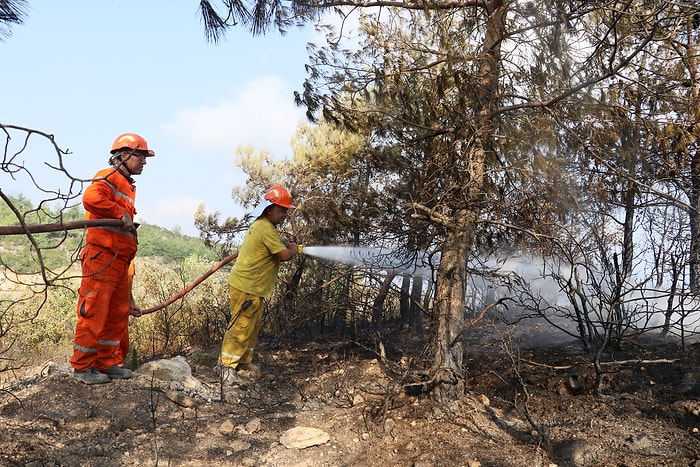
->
[219,287,263,368]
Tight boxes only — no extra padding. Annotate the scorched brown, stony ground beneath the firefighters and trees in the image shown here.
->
[0,322,700,467]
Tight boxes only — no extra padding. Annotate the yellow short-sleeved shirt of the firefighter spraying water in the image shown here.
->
[228,217,287,298]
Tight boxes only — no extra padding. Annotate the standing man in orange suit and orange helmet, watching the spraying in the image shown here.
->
[71,133,155,384]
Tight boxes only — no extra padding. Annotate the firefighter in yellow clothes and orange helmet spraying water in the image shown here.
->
[219,185,299,383]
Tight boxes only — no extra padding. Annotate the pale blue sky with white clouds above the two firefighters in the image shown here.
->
[0,0,315,235]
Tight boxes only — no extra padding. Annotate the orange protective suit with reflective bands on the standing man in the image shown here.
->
[71,167,138,371]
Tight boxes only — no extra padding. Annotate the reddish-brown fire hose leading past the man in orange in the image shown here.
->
[0,219,238,316]
